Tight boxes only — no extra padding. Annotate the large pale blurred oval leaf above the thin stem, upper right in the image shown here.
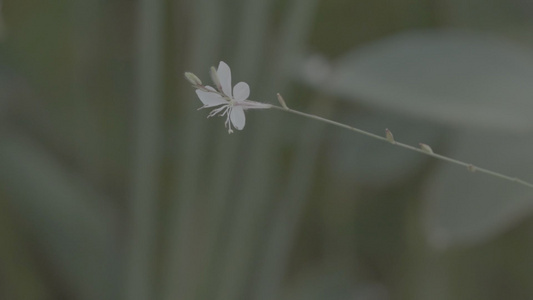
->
[329,30,533,130]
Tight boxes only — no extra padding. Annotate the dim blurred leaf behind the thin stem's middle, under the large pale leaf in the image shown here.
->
[329,113,444,185]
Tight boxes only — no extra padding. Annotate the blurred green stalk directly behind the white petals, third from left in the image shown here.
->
[198,0,274,300]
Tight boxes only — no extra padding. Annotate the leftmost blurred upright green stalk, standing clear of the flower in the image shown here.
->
[124,0,163,300]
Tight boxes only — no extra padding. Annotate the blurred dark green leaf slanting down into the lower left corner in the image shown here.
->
[0,133,118,299]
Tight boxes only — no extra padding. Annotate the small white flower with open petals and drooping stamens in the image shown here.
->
[196,61,272,133]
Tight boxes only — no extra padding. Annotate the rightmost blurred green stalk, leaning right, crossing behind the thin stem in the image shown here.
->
[216,0,318,300]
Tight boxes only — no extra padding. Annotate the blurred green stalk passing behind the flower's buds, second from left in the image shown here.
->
[161,0,225,300]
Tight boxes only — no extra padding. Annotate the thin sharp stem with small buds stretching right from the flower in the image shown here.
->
[272,105,533,188]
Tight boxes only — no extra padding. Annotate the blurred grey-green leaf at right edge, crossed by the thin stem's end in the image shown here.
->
[426,131,533,247]
